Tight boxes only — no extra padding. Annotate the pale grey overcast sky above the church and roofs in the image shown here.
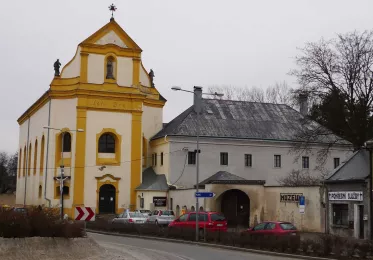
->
[0,0,373,152]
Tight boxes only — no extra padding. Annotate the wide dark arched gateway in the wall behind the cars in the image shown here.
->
[221,189,250,227]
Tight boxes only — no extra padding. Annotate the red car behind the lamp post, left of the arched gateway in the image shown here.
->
[168,211,227,232]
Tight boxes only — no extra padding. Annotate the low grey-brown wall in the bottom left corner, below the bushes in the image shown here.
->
[0,237,102,260]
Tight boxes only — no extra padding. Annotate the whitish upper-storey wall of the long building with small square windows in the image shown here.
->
[169,137,350,187]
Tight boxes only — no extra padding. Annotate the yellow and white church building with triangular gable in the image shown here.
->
[16,19,166,217]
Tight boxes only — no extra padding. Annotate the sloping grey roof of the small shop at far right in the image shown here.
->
[325,149,370,183]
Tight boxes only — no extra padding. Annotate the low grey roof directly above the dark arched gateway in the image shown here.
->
[199,171,265,186]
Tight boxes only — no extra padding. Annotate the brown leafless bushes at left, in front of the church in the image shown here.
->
[0,208,84,238]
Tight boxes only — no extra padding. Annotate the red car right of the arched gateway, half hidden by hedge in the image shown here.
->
[244,221,298,236]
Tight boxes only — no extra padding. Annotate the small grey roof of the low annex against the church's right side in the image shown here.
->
[136,167,168,191]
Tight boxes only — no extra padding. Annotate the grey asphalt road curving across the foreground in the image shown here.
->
[89,233,295,260]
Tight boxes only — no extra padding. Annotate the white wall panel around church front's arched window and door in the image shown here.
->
[84,111,132,208]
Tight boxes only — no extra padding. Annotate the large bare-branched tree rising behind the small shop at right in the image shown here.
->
[290,31,373,165]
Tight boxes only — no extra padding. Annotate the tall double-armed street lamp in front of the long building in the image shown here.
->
[171,86,224,241]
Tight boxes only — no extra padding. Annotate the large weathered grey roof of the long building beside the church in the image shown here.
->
[152,99,346,142]
